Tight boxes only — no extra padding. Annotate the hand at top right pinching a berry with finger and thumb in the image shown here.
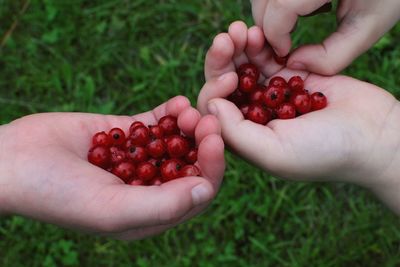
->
[251,0,400,75]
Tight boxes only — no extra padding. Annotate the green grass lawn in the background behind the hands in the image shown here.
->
[0,0,400,267]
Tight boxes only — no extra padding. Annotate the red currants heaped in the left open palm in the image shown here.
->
[88,115,200,185]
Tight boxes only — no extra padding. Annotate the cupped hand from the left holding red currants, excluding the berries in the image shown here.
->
[0,96,225,240]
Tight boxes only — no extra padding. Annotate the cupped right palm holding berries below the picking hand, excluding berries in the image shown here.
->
[198,22,400,213]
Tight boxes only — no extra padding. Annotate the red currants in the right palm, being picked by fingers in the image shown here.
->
[228,63,327,125]
